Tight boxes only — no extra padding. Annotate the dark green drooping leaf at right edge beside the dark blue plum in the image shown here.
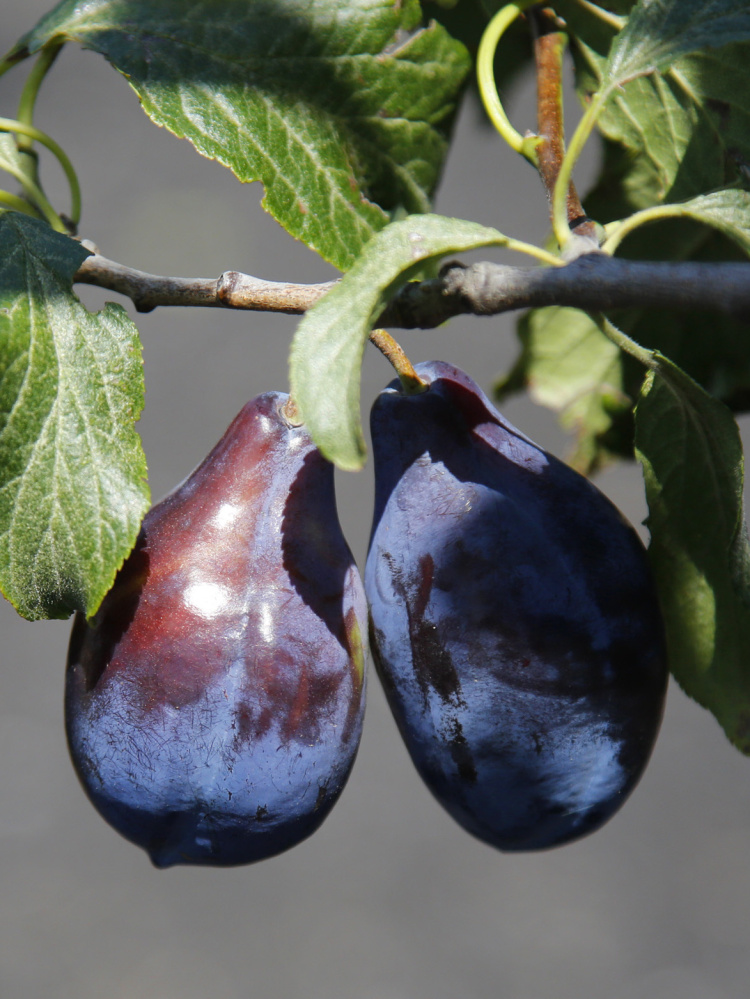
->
[636,355,750,753]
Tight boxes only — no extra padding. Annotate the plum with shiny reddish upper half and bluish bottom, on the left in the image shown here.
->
[66,393,366,867]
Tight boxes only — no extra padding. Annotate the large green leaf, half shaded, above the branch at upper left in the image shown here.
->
[17,0,470,269]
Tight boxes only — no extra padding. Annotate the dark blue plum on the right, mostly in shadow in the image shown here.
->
[365,362,667,850]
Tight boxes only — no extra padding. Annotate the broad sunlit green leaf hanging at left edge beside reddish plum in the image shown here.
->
[0,212,149,620]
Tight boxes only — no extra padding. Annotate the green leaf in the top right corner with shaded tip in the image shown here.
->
[603,0,750,89]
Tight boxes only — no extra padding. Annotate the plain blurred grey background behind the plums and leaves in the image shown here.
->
[0,0,750,999]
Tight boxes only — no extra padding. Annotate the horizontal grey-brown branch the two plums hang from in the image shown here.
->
[75,253,750,329]
